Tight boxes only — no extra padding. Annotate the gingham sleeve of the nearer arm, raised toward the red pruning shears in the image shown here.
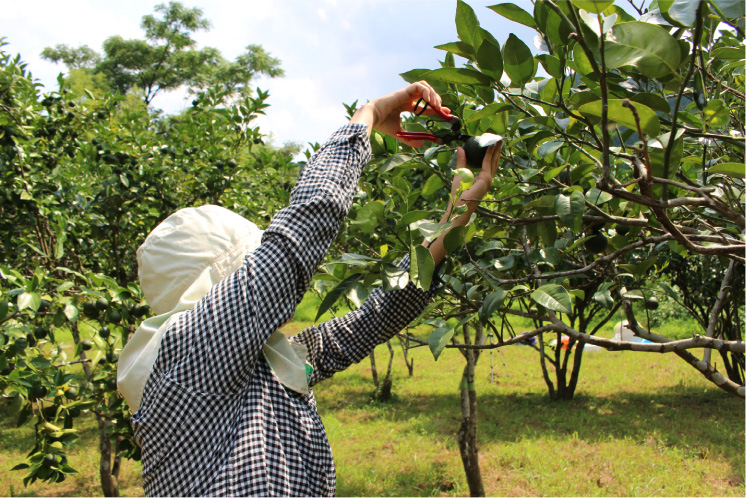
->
[156,124,370,394]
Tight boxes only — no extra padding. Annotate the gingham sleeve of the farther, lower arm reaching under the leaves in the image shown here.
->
[291,256,440,386]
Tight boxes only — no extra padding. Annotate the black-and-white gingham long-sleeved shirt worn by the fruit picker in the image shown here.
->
[132,125,433,496]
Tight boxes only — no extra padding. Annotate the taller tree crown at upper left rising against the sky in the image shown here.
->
[41,2,283,105]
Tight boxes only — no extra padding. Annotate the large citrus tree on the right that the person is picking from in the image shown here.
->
[318,0,745,494]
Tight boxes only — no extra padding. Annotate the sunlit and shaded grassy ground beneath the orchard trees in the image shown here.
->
[0,300,745,496]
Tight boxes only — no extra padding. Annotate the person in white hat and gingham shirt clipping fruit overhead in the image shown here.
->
[117,82,500,496]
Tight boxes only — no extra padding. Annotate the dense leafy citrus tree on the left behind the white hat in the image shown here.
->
[0,40,297,496]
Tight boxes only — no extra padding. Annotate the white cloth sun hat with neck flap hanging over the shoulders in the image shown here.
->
[117,205,308,413]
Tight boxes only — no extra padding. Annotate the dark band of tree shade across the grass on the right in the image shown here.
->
[319,378,744,482]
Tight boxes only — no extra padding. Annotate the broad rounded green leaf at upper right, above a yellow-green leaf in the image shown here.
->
[604,21,681,78]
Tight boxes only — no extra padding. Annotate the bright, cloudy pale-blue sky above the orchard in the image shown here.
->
[0,0,536,151]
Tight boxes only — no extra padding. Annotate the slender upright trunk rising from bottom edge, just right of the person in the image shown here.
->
[458,324,484,496]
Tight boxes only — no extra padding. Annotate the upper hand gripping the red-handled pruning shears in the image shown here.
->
[366,81,450,147]
